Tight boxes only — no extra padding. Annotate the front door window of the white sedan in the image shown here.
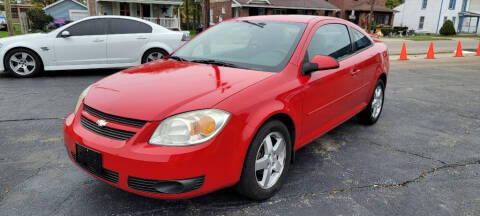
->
[65,19,106,36]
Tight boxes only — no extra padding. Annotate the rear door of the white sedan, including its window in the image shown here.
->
[107,18,152,64]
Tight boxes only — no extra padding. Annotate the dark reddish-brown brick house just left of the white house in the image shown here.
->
[328,0,395,28]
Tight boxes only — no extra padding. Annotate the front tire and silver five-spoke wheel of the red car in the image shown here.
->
[235,120,292,200]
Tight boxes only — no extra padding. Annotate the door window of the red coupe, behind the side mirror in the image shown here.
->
[307,24,352,61]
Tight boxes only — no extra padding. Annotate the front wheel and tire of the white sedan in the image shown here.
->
[3,48,43,78]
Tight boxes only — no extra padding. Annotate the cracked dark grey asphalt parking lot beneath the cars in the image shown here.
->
[0,57,480,215]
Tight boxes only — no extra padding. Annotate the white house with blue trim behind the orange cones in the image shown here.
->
[394,0,480,33]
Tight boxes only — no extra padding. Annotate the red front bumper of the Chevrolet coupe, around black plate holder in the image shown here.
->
[64,105,243,199]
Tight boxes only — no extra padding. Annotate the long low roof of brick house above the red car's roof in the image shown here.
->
[233,0,340,10]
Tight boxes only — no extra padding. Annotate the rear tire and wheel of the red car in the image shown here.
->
[357,79,385,125]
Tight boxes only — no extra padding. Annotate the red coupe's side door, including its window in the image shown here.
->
[303,23,356,136]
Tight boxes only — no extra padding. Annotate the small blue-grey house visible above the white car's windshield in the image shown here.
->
[43,0,88,21]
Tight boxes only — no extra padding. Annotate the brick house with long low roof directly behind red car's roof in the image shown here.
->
[210,0,340,24]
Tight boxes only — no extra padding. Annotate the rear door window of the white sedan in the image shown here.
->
[109,18,152,34]
